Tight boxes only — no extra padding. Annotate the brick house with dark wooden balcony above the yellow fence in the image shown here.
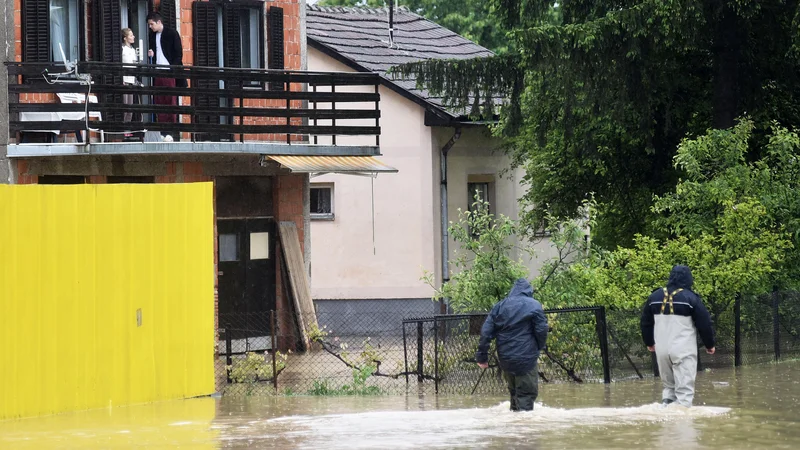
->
[0,0,394,356]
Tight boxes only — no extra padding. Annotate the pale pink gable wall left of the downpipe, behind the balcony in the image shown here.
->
[308,48,438,299]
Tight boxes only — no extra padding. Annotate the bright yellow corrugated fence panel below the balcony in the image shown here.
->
[0,183,214,419]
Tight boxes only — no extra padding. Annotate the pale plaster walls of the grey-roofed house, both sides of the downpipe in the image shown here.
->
[308,48,552,299]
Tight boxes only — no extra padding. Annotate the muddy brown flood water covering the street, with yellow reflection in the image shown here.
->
[0,362,800,449]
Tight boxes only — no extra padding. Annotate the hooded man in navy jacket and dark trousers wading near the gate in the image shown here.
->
[475,278,548,411]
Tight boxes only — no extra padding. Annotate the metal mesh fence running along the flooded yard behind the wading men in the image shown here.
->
[217,292,800,395]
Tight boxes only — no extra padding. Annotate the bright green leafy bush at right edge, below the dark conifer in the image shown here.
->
[653,120,800,288]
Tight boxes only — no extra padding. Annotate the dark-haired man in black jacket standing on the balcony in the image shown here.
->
[147,11,186,142]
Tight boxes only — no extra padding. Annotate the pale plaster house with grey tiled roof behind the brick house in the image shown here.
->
[306,6,552,327]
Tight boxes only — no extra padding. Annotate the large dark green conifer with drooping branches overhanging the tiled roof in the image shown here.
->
[398,0,800,249]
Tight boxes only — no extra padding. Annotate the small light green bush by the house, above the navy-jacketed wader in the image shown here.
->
[423,198,528,312]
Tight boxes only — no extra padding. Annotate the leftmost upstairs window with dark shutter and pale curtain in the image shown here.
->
[22,0,84,62]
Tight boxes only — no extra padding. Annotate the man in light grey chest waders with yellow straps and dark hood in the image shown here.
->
[641,266,715,407]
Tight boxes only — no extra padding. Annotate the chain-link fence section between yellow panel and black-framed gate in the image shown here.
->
[216,302,440,395]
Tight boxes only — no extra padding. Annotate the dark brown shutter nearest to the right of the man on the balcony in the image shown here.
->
[192,1,219,123]
